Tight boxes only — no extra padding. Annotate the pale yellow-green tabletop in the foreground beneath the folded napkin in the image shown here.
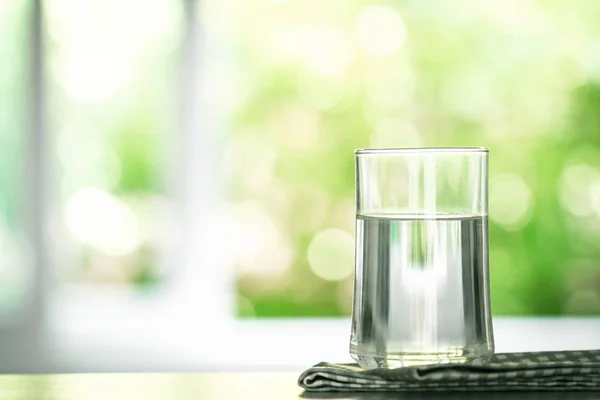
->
[0,372,600,400]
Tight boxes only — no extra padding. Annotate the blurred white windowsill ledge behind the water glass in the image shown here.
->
[0,317,600,374]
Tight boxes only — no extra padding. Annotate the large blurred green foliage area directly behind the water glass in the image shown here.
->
[222,0,600,317]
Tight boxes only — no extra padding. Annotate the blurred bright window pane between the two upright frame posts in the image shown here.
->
[44,0,183,291]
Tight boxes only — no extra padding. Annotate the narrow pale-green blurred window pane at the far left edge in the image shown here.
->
[0,0,34,325]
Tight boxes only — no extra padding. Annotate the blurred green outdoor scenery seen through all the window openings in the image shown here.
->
[0,0,600,317]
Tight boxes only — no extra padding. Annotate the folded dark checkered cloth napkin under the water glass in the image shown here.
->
[298,350,600,392]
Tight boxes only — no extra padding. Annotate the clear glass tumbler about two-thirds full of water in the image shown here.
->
[350,147,494,369]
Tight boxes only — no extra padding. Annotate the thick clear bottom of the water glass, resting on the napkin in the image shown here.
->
[350,343,494,369]
